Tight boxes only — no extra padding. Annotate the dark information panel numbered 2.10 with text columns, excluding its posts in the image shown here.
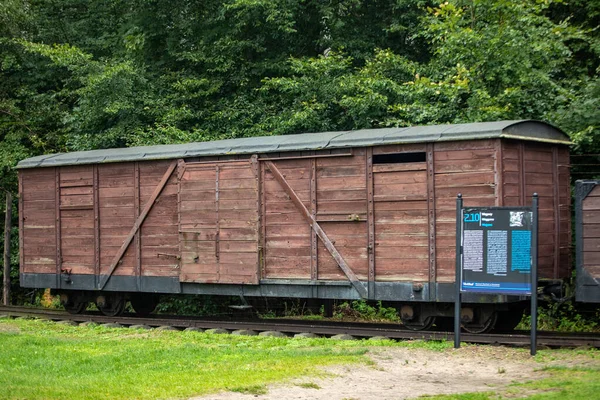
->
[460,207,533,295]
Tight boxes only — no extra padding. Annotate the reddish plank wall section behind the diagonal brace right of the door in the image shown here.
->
[262,149,368,280]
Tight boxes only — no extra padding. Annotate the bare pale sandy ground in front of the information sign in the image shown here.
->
[194,346,600,400]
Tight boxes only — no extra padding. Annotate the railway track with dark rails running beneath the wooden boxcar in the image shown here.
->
[0,306,600,348]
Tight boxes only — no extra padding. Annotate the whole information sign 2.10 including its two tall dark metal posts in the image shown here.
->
[454,193,538,355]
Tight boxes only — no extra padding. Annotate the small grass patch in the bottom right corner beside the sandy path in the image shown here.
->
[421,367,600,400]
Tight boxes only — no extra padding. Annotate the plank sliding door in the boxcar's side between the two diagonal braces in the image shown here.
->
[179,159,259,284]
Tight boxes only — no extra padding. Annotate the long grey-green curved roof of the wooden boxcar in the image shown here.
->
[17,120,571,169]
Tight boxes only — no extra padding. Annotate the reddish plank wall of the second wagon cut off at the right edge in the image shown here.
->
[582,186,600,280]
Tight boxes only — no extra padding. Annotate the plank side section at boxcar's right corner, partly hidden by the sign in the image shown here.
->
[434,140,498,282]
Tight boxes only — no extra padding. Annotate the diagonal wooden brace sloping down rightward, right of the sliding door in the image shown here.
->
[265,161,368,299]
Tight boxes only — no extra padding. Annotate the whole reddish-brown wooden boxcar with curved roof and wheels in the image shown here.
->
[18,121,571,327]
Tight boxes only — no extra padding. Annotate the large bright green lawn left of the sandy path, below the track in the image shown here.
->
[0,319,450,399]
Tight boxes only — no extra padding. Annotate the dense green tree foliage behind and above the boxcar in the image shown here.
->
[0,0,600,296]
